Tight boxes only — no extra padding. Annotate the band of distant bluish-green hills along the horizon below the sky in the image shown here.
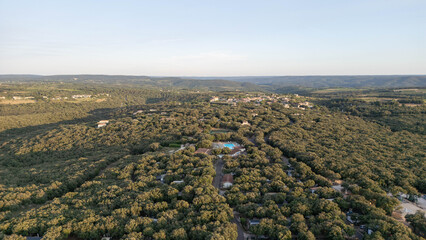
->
[0,75,426,92]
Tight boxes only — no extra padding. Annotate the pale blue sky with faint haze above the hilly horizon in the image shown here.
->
[0,0,426,76]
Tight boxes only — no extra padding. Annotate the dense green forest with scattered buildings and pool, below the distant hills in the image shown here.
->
[0,82,426,240]
